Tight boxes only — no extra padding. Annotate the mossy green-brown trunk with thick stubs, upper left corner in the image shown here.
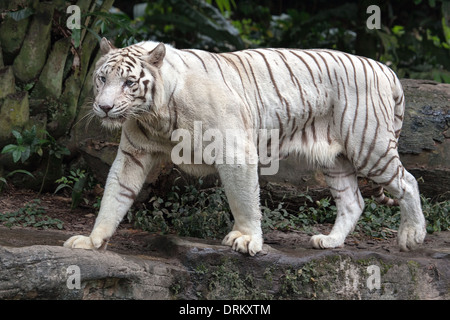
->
[0,0,113,190]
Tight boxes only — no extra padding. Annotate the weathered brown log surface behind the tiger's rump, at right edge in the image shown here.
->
[399,79,450,199]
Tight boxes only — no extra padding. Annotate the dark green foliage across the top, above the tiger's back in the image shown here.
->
[100,0,450,82]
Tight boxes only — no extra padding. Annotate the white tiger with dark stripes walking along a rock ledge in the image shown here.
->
[64,38,426,255]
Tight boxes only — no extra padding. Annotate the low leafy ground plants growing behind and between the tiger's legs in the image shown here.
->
[128,180,450,239]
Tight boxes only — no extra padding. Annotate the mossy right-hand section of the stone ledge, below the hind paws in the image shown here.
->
[172,240,448,300]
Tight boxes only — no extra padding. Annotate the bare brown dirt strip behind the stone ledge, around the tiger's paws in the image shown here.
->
[0,188,450,255]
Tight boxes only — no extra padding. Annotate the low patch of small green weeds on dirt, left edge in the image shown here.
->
[0,199,63,229]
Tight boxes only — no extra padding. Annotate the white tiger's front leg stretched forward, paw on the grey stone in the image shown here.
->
[64,139,154,249]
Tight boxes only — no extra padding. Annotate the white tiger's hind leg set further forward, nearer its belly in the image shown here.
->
[310,156,364,249]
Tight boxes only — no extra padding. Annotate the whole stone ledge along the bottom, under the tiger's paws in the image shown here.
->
[0,227,450,300]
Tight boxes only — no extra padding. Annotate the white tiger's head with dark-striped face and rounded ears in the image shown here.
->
[93,38,166,128]
